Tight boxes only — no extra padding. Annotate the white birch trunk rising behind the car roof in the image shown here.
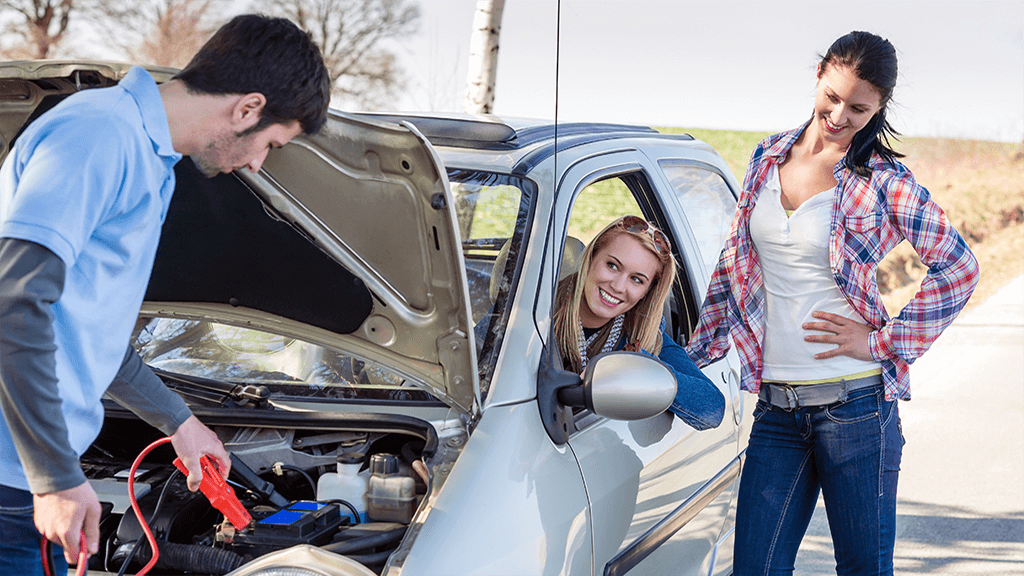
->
[466,0,505,114]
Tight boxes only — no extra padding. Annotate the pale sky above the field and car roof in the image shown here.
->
[385,0,1024,142]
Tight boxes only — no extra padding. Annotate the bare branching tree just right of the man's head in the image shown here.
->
[257,0,420,110]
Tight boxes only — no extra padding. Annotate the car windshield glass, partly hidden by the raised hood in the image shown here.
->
[132,170,532,401]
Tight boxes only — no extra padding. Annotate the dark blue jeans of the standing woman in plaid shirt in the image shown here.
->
[733,385,903,576]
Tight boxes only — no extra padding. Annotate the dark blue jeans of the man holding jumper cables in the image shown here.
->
[0,486,68,576]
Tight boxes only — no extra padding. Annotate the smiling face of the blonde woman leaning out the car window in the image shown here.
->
[580,229,662,328]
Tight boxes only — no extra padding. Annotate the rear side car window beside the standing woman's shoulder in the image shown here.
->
[660,161,736,290]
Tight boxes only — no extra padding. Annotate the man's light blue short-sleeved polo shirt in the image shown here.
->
[0,68,181,490]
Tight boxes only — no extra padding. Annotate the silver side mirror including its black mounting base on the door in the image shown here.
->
[537,344,676,445]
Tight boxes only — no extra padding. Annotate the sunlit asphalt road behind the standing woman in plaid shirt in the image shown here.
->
[796,276,1024,576]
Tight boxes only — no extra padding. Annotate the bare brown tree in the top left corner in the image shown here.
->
[0,0,78,58]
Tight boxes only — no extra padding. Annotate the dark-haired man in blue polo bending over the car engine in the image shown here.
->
[0,15,330,576]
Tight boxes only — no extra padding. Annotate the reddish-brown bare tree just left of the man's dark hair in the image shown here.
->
[90,0,226,68]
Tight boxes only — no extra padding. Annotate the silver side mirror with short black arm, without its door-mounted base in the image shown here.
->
[557,352,676,420]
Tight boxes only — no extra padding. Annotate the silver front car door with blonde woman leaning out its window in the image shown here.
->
[550,147,738,574]
